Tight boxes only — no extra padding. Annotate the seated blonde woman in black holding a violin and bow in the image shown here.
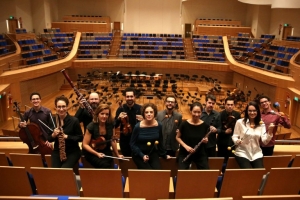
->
[82,104,123,168]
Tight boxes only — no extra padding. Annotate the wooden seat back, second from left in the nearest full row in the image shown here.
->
[30,167,79,196]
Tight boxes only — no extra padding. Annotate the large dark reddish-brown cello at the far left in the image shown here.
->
[14,102,52,156]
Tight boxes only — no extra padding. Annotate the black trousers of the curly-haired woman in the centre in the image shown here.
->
[132,151,161,169]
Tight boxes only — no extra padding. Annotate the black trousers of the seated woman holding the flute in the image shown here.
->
[177,151,209,169]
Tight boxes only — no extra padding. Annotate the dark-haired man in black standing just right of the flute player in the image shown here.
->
[200,94,222,157]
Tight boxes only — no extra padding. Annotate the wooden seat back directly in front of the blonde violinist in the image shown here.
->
[79,169,123,198]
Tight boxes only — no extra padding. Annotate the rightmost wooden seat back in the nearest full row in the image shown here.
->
[262,167,300,195]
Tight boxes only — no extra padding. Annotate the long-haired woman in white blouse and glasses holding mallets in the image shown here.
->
[232,101,274,169]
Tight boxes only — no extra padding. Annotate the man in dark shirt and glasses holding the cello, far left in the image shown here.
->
[19,92,53,148]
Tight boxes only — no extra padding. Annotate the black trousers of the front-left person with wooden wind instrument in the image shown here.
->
[51,149,81,168]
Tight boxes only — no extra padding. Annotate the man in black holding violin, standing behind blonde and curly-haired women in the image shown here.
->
[115,88,143,156]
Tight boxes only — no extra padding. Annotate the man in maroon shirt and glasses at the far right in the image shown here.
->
[259,95,291,156]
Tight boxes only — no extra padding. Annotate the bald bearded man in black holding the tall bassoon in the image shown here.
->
[75,92,100,133]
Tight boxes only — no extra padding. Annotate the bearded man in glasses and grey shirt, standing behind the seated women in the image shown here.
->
[157,96,182,157]
